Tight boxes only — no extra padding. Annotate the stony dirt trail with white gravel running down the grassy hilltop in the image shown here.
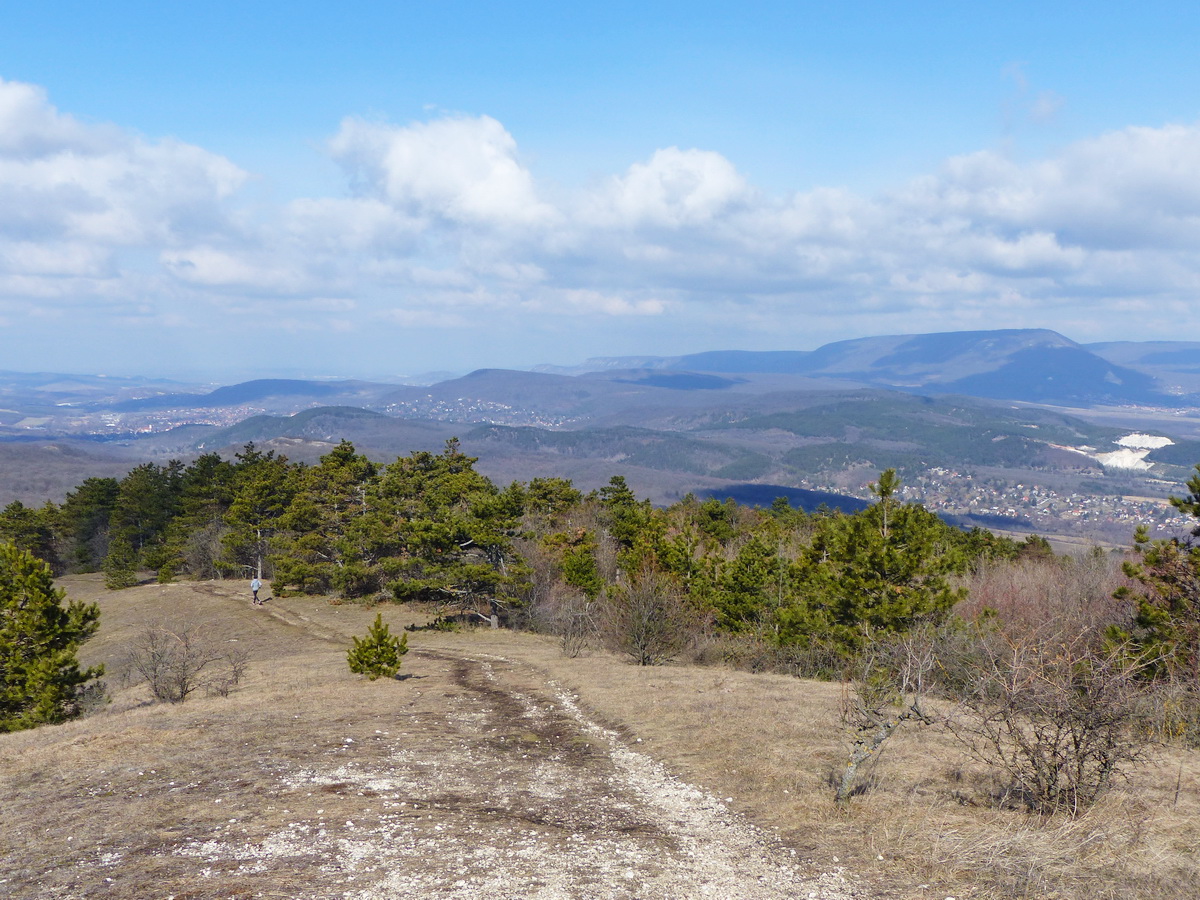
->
[174,606,862,900]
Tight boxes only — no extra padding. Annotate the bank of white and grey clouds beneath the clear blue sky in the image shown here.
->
[0,68,1200,374]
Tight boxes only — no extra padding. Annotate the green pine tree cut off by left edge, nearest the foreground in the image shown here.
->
[0,544,103,732]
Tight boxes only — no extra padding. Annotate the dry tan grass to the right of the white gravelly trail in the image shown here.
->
[410,632,1200,900]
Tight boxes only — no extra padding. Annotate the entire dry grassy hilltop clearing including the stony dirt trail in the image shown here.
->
[0,576,1200,900]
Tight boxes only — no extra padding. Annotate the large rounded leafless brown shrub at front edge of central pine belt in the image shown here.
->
[605,566,692,666]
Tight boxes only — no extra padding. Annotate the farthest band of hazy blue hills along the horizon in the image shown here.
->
[7,329,1180,425]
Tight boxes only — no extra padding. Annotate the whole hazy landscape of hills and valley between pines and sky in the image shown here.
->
[0,330,1200,549]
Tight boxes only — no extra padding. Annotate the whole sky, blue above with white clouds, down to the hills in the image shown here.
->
[0,1,1200,380]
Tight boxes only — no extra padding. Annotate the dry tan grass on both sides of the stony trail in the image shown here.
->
[0,576,1200,900]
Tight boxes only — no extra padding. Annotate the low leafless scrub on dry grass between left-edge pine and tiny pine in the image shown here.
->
[126,623,248,703]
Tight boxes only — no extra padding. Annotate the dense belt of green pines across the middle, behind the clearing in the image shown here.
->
[0,440,1037,653]
